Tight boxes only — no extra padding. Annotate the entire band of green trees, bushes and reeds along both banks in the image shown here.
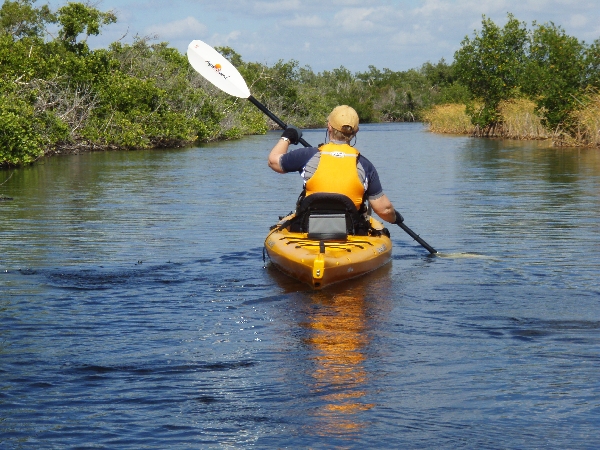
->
[0,0,600,167]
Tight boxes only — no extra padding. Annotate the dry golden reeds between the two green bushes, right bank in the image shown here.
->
[498,98,550,139]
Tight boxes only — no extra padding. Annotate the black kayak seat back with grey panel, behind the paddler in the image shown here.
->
[290,192,369,240]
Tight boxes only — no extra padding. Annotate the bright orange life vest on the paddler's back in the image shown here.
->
[305,143,365,209]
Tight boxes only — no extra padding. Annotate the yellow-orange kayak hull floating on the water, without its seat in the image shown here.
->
[265,214,392,289]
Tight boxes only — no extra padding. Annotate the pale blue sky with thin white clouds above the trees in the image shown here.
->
[63,0,600,72]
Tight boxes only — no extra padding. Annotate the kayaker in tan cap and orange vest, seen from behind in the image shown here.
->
[269,105,404,225]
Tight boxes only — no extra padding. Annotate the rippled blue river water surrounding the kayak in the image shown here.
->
[0,124,600,449]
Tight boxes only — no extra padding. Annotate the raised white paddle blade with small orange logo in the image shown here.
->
[188,40,250,98]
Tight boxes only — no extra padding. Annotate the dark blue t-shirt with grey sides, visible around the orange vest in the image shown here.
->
[279,147,383,200]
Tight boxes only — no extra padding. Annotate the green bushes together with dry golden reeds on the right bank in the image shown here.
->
[424,14,600,147]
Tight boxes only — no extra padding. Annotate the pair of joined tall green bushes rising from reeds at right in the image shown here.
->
[454,14,600,130]
